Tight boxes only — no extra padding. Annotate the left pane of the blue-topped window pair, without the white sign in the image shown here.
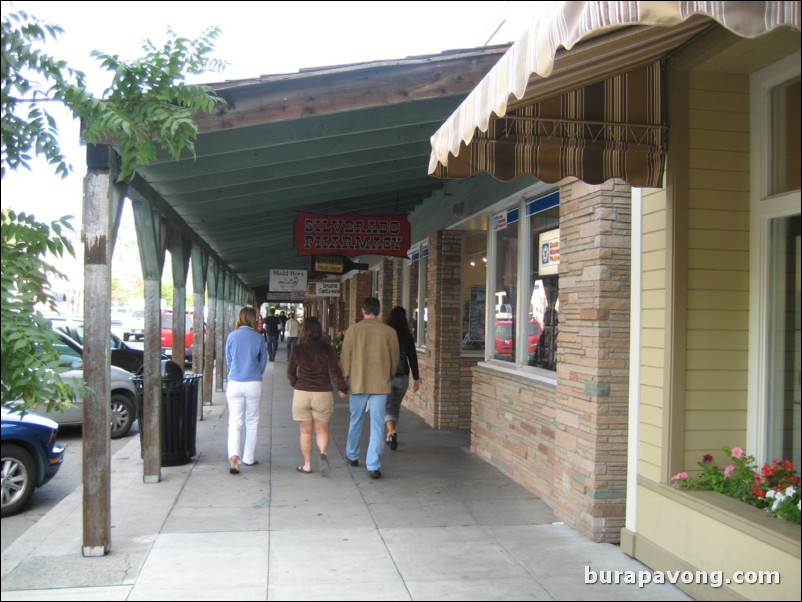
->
[488,207,518,362]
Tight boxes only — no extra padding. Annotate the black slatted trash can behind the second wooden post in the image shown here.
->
[132,360,203,466]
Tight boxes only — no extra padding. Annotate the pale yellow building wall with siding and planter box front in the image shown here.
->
[622,49,800,600]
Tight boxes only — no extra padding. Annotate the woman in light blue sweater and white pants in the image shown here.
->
[225,307,267,474]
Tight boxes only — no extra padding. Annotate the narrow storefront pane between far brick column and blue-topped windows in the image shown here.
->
[462,232,487,351]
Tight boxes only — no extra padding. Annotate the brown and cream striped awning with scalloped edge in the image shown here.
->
[429,2,800,187]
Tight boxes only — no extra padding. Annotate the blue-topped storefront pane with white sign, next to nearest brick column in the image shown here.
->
[526,192,560,370]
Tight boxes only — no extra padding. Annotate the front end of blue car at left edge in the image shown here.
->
[1,407,64,516]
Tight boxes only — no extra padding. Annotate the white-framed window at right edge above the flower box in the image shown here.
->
[747,53,802,466]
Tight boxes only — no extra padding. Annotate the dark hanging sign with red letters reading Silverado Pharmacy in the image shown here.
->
[294,211,410,257]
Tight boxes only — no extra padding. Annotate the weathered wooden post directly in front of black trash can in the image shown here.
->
[131,200,167,483]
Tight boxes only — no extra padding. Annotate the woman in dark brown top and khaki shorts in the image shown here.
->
[287,314,348,477]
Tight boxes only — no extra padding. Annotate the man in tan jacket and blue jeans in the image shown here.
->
[340,297,400,479]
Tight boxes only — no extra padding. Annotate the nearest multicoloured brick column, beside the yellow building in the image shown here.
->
[553,180,631,541]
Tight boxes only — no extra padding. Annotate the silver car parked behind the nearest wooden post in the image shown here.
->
[39,330,137,439]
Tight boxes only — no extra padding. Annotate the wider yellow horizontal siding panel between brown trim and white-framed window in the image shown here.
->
[677,72,749,469]
